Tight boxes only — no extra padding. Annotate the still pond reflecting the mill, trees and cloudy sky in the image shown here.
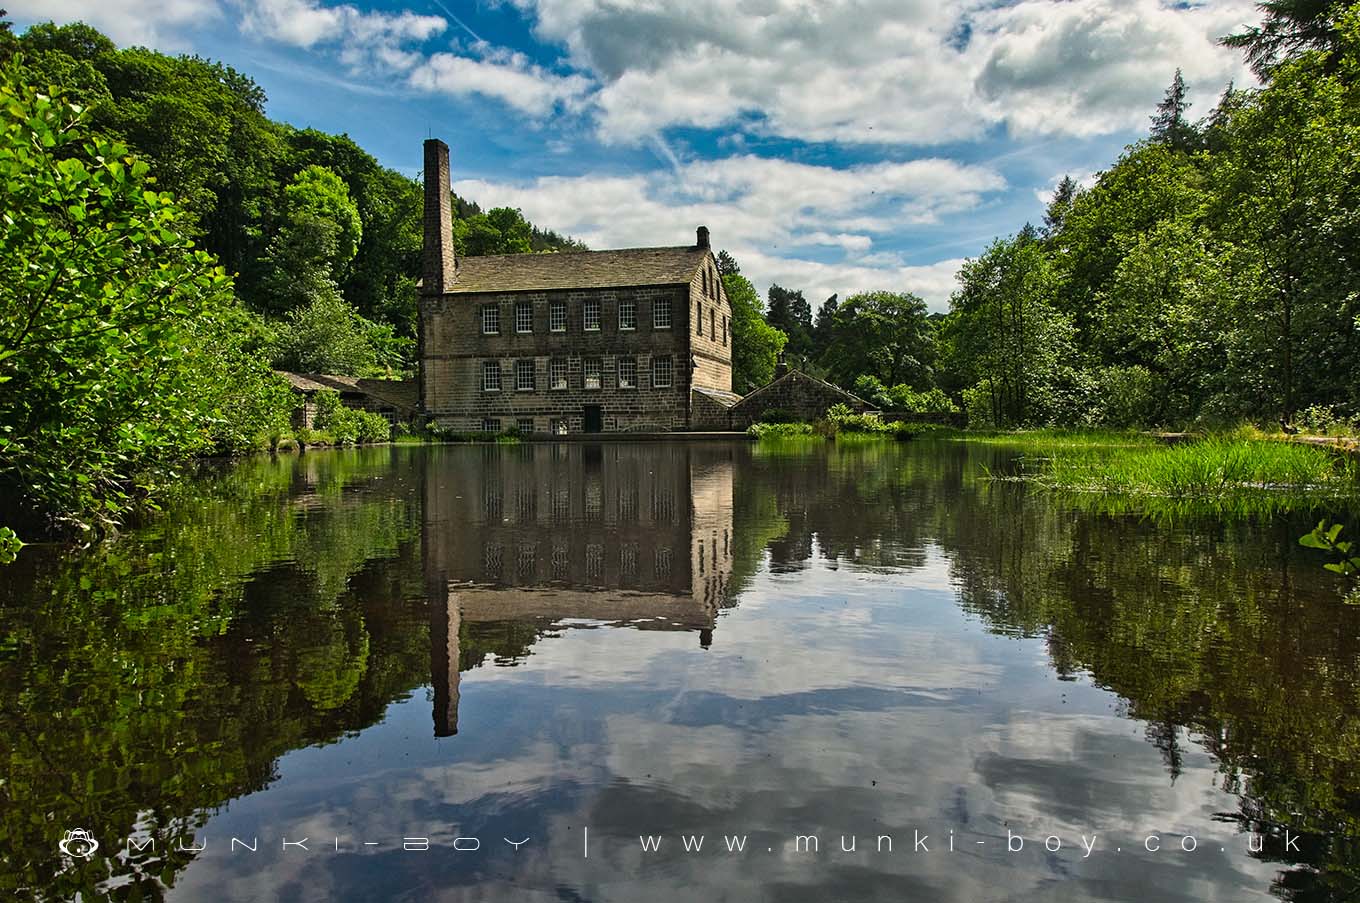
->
[0,442,1360,903]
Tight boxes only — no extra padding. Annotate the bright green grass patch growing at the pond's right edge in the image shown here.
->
[1020,435,1360,500]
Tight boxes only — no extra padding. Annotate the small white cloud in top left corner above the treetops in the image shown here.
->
[4,0,222,50]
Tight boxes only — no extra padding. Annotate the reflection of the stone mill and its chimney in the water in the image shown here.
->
[424,443,733,736]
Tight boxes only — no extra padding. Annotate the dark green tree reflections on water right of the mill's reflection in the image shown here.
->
[736,443,1360,900]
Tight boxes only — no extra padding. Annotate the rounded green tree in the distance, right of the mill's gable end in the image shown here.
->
[823,291,934,389]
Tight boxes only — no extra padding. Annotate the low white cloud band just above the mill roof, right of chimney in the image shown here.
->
[454,156,1005,309]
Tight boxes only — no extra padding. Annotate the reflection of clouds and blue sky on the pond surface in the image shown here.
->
[167,549,1270,903]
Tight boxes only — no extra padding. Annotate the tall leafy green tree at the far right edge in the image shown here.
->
[1212,23,1360,419]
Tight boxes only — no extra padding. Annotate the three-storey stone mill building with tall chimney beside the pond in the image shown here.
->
[419,139,738,434]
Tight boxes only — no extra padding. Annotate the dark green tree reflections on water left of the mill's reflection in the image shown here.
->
[0,450,427,899]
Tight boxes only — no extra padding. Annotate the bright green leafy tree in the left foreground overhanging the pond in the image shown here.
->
[0,65,286,528]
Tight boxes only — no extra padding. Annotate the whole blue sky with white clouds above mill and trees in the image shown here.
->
[4,0,1259,310]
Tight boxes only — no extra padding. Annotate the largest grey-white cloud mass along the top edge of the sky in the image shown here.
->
[514,0,1258,144]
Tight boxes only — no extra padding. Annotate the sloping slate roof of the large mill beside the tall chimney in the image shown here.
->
[449,245,709,294]
